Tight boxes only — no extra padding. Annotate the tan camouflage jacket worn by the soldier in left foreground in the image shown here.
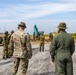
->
[10,30,32,58]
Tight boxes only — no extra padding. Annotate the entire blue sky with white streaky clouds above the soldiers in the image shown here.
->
[0,0,76,34]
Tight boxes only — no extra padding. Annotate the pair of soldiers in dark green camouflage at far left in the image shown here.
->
[2,30,14,59]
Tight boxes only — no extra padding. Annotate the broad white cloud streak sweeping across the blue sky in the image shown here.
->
[0,3,76,22]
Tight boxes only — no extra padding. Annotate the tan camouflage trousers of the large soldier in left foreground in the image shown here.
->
[12,58,28,75]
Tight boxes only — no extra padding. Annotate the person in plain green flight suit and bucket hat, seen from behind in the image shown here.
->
[50,22,75,75]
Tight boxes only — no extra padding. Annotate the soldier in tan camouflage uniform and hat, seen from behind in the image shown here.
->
[10,22,32,75]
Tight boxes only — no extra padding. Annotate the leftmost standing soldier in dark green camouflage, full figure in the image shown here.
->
[3,31,9,59]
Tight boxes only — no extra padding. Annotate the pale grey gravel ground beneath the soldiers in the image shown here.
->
[0,44,76,75]
